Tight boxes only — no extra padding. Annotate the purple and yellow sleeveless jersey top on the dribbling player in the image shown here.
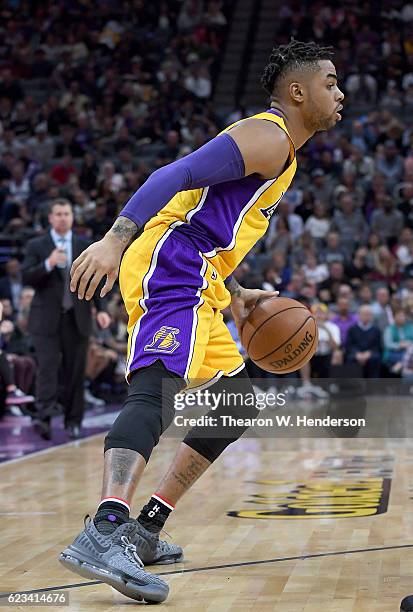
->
[145,110,297,279]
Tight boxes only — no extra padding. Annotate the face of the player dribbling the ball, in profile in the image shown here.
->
[303,60,344,132]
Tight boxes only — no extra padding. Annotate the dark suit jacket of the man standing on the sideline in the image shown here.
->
[22,232,104,336]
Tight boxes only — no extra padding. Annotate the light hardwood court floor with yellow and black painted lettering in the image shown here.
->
[0,435,413,612]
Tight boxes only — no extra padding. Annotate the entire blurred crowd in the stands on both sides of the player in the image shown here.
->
[0,0,413,416]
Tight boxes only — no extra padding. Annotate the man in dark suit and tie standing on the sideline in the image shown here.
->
[22,198,110,439]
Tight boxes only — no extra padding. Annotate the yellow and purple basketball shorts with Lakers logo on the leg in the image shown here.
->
[119,225,244,387]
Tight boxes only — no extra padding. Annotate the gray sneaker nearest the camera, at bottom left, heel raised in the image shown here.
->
[59,516,169,603]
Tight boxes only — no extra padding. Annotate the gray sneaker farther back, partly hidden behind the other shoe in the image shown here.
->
[130,519,184,565]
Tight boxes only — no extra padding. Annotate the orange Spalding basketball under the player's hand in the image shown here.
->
[241,297,318,374]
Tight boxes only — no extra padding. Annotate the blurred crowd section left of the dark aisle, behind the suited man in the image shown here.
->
[0,0,232,416]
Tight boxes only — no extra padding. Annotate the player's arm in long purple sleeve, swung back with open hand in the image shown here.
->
[71,119,290,299]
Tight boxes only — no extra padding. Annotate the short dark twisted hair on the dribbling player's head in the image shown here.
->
[261,39,334,96]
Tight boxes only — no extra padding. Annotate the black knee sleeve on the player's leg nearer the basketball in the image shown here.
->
[184,368,259,463]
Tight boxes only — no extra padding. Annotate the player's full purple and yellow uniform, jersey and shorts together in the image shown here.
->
[119,111,297,387]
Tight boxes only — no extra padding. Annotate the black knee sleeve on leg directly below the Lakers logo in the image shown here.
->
[105,361,185,462]
